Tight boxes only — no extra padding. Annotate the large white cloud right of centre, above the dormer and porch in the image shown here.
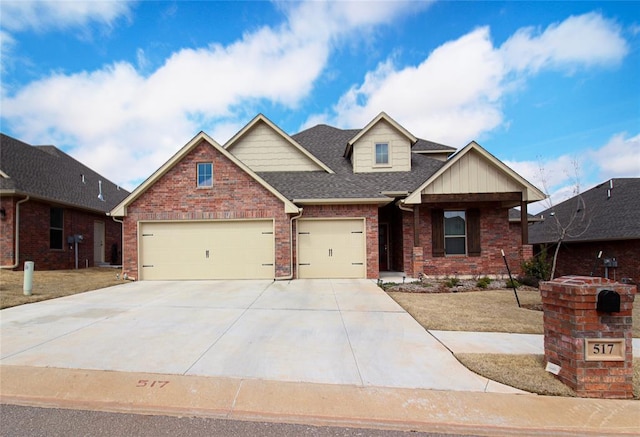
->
[305,13,629,147]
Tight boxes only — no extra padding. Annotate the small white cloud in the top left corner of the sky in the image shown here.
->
[0,0,131,32]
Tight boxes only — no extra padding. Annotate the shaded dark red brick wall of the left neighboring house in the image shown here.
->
[0,197,122,270]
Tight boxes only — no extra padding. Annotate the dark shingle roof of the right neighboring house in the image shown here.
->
[529,178,640,244]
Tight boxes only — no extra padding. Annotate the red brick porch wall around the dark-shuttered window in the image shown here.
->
[402,205,532,277]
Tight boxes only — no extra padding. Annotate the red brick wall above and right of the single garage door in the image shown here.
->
[302,205,379,279]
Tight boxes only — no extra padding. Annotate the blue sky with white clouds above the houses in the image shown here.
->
[0,0,640,212]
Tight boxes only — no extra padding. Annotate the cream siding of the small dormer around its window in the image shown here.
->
[351,121,411,173]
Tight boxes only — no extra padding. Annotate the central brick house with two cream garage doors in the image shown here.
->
[111,113,545,280]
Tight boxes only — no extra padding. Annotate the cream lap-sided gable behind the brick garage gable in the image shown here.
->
[224,114,333,173]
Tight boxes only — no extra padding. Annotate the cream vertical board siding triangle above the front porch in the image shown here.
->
[422,151,524,194]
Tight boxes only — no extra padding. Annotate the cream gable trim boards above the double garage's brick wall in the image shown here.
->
[110,132,299,217]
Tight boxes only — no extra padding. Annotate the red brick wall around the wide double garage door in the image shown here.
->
[123,141,290,279]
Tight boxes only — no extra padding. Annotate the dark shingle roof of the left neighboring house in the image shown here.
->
[0,134,129,213]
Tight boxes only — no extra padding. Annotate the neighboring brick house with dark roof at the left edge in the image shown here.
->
[0,134,129,270]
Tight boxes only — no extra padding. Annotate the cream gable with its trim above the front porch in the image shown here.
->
[405,141,546,204]
